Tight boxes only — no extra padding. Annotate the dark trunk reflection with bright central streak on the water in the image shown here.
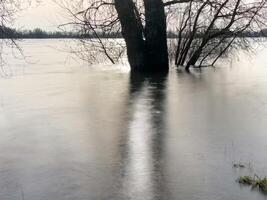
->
[116,73,167,200]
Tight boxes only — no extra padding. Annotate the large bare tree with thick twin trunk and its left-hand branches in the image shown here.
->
[57,0,200,72]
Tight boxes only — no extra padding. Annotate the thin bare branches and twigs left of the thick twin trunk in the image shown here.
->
[55,0,125,64]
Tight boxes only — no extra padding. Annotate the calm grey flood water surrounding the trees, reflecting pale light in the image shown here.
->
[0,40,267,200]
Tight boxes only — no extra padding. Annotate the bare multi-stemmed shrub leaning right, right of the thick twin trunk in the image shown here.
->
[172,0,267,70]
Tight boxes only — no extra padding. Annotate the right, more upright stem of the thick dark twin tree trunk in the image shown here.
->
[144,0,169,72]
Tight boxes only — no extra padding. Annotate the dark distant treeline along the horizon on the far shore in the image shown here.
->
[0,27,267,39]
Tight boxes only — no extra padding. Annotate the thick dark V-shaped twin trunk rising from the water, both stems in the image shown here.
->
[115,0,169,72]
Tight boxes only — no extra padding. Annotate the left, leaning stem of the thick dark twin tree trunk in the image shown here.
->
[115,0,145,71]
